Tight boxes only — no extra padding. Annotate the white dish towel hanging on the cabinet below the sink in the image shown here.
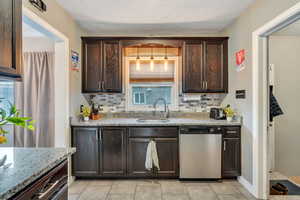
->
[145,140,160,170]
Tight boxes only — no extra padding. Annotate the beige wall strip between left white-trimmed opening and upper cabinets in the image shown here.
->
[23,0,86,116]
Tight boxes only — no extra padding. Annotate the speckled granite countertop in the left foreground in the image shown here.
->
[0,148,76,199]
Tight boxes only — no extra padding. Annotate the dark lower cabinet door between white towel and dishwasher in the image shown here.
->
[155,138,179,178]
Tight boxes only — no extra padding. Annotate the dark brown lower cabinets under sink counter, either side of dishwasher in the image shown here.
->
[72,127,241,178]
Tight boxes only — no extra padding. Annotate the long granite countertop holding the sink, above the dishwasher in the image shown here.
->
[71,118,242,126]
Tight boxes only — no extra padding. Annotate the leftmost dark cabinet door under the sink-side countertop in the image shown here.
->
[72,128,99,177]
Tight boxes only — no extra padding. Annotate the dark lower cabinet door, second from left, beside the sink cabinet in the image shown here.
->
[100,128,126,177]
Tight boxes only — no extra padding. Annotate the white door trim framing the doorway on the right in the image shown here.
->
[252,3,300,199]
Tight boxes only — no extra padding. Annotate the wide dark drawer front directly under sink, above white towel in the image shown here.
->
[129,127,178,138]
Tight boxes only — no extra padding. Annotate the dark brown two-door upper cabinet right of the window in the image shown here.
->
[182,38,228,93]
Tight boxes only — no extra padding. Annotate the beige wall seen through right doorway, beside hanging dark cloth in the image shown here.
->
[269,36,300,176]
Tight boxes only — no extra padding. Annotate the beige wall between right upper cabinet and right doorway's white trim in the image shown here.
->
[223,0,299,183]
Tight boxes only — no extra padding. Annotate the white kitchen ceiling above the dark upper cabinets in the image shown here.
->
[57,0,254,35]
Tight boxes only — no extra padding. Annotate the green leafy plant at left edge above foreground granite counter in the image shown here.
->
[0,101,35,144]
